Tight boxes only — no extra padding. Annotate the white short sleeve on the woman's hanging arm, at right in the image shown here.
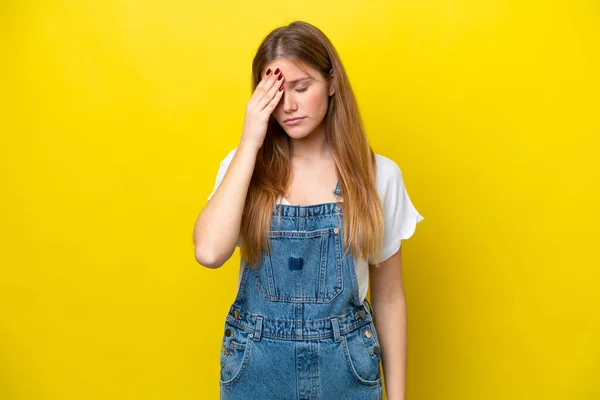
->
[368,158,424,264]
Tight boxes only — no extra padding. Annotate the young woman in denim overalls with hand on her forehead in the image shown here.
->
[194,21,423,400]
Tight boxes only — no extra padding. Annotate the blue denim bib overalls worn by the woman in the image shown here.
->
[220,181,382,400]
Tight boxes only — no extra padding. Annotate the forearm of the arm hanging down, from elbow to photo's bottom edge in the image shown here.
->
[372,295,407,400]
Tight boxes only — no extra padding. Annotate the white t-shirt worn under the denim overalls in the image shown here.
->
[208,148,423,302]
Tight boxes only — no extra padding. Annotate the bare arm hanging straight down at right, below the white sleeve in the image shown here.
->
[369,247,407,400]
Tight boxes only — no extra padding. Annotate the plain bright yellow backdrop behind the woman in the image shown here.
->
[0,0,600,400]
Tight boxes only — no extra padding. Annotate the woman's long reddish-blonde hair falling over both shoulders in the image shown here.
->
[240,21,383,268]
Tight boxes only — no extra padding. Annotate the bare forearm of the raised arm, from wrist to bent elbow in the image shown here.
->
[194,141,258,268]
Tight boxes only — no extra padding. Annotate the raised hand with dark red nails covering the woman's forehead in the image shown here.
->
[241,68,284,149]
